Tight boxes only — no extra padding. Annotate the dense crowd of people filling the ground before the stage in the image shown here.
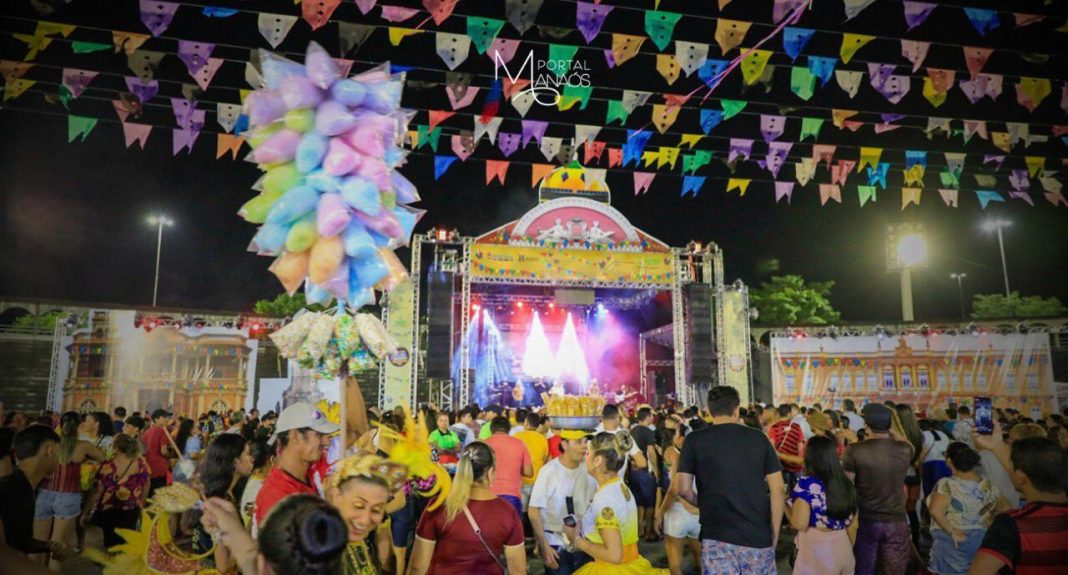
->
[0,386,1068,575]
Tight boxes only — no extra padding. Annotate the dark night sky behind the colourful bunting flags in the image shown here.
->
[0,0,1068,322]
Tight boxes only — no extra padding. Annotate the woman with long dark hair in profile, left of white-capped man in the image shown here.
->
[189,433,252,573]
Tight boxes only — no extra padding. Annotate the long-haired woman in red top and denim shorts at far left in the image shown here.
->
[33,411,105,570]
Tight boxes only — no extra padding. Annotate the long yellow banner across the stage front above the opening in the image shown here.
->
[471,244,674,288]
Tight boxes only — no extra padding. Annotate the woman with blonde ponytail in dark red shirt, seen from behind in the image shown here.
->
[408,440,527,575]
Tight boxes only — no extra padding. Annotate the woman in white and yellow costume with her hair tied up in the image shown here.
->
[564,432,668,575]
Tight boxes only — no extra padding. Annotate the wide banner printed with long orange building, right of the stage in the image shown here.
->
[771,333,1058,419]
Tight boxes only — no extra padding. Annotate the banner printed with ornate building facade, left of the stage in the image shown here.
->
[57,310,260,418]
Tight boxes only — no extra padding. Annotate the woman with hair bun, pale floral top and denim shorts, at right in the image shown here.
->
[927,441,1009,575]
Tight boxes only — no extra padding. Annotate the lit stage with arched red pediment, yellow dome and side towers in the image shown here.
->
[379,165,752,407]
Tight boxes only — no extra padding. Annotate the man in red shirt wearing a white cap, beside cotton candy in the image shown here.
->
[255,403,341,525]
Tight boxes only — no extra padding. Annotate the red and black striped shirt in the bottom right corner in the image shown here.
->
[979,502,1068,575]
